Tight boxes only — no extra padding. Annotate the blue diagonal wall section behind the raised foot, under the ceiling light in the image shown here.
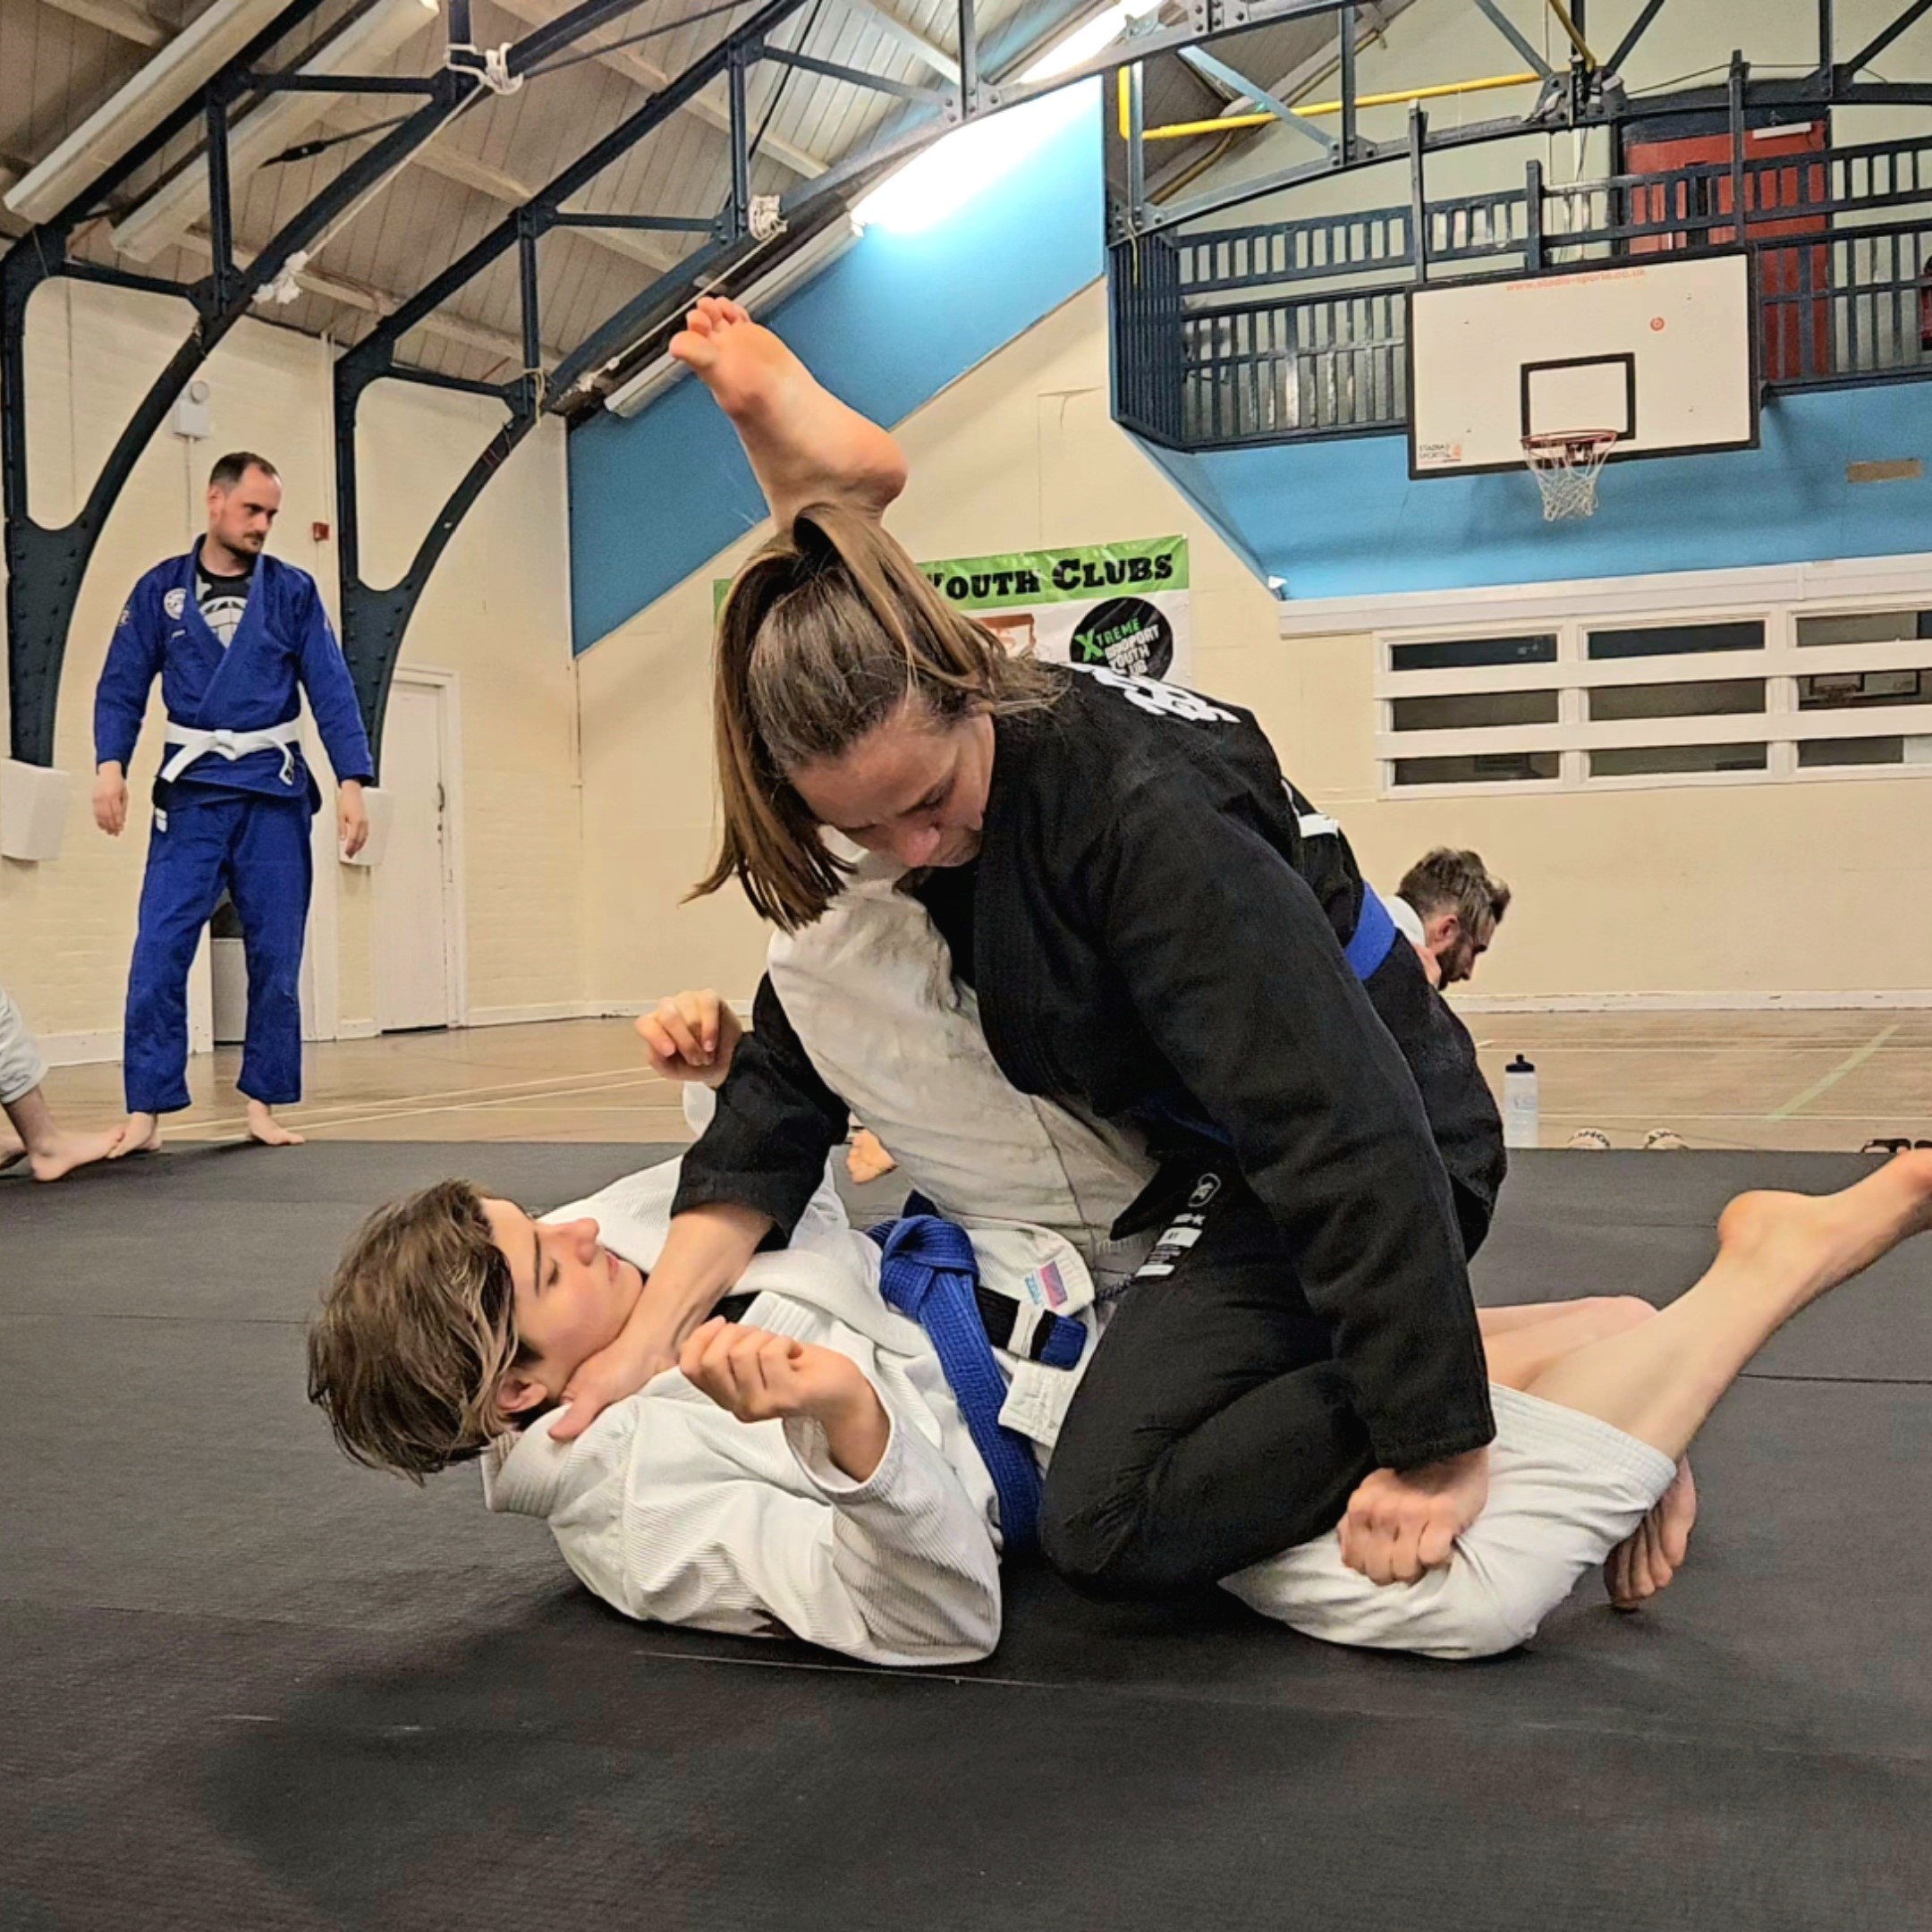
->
[568,99,1106,651]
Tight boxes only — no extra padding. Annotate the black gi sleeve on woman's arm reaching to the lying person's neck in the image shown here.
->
[671,974,850,1236]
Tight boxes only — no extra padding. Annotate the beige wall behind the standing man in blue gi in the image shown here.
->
[0,282,581,1059]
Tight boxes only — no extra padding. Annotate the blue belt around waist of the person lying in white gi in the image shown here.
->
[869,1216,1039,1551]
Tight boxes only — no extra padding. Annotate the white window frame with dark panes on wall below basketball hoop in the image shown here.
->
[1368,587,1932,800]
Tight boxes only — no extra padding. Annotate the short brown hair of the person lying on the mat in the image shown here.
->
[309,1181,533,1482]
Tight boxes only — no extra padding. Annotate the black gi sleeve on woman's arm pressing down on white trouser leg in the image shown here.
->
[1088,767,1496,1469]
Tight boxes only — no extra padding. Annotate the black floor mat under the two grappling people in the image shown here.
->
[0,1144,1932,1932]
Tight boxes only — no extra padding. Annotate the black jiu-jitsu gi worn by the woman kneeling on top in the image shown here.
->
[678,673,1503,1592]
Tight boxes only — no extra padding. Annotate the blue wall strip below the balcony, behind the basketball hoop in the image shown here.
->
[1148,383,1932,599]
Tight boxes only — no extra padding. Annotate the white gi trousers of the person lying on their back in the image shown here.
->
[761,860,1675,1657]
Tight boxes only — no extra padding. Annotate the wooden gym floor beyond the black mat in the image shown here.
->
[26,1011,1932,1149]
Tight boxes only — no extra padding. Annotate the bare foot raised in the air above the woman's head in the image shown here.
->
[671,295,906,530]
